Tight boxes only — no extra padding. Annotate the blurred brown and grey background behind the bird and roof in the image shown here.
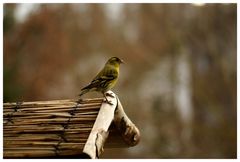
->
[3,4,237,158]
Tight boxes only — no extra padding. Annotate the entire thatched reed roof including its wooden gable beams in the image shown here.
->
[3,90,140,158]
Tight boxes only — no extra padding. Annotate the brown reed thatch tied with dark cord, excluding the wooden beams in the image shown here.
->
[3,99,102,158]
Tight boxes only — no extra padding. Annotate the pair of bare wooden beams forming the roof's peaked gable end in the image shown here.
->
[83,91,140,159]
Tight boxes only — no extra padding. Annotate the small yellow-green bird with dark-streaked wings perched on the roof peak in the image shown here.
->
[79,57,124,105]
